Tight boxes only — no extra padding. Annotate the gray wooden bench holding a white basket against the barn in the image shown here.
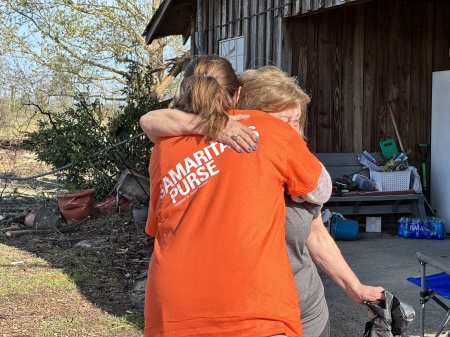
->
[315,153,426,217]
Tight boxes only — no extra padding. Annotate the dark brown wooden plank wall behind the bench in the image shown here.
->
[287,0,450,166]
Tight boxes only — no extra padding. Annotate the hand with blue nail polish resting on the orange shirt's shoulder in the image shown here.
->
[217,115,258,152]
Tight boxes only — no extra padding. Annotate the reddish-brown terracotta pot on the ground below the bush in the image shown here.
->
[58,189,95,223]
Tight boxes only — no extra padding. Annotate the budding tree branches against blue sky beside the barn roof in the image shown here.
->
[0,0,183,98]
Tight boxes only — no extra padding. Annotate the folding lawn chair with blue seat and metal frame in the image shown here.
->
[407,252,450,337]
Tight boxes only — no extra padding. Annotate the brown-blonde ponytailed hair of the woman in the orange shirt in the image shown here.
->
[174,55,239,139]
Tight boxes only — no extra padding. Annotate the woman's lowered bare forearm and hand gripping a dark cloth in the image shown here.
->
[306,216,384,304]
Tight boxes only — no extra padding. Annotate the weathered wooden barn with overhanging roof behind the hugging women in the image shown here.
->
[144,0,450,202]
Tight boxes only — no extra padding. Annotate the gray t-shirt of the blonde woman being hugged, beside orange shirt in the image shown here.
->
[285,196,329,337]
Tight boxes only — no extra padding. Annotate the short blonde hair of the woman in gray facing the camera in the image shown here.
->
[237,66,310,137]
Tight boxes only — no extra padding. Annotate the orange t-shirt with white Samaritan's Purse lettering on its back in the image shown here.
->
[144,110,322,337]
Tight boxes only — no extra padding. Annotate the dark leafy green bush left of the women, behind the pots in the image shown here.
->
[28,66,159,200]
